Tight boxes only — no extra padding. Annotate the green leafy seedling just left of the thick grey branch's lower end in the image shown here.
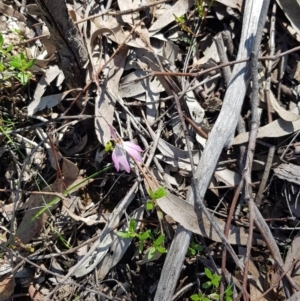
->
[117,219,167,260]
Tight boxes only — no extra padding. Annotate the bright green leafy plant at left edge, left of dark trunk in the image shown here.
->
[0,34,35,85]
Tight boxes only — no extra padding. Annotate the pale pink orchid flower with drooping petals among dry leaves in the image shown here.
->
[109,125,143,173]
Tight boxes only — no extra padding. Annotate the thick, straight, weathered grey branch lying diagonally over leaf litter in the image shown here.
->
[154,0,262,301]
